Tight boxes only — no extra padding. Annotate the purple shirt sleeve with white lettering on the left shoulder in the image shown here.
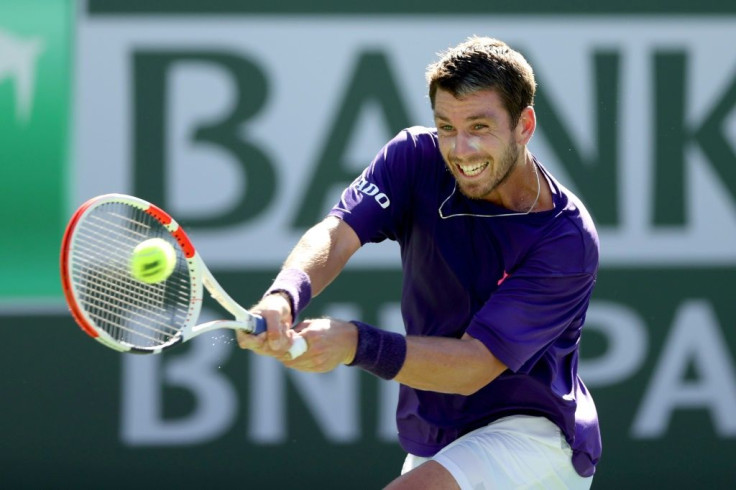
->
[329,131,417,244]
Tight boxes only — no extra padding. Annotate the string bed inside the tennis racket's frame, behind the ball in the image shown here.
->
[70,203,191,348]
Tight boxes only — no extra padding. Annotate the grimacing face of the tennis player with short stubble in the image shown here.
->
[434,89,521,200]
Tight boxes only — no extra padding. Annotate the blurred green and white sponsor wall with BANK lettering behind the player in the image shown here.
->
[0,0,736,489]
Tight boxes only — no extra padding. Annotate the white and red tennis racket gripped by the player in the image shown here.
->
[61,194,307,358]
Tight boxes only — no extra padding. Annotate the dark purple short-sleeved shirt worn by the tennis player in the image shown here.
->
[330,127,601,476]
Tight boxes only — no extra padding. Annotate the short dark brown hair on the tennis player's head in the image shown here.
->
[426,36,537,127]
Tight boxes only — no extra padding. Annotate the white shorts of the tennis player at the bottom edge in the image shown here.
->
[401,415,593,490]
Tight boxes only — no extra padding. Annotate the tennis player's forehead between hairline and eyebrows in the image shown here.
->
[434,89,508,121]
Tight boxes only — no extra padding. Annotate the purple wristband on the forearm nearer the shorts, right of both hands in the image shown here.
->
[348,321,406,379]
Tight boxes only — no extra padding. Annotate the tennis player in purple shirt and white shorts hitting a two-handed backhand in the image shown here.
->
[238,37,601,490]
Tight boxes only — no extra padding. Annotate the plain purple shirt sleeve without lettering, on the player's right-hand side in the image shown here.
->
[466,234,595,373]
